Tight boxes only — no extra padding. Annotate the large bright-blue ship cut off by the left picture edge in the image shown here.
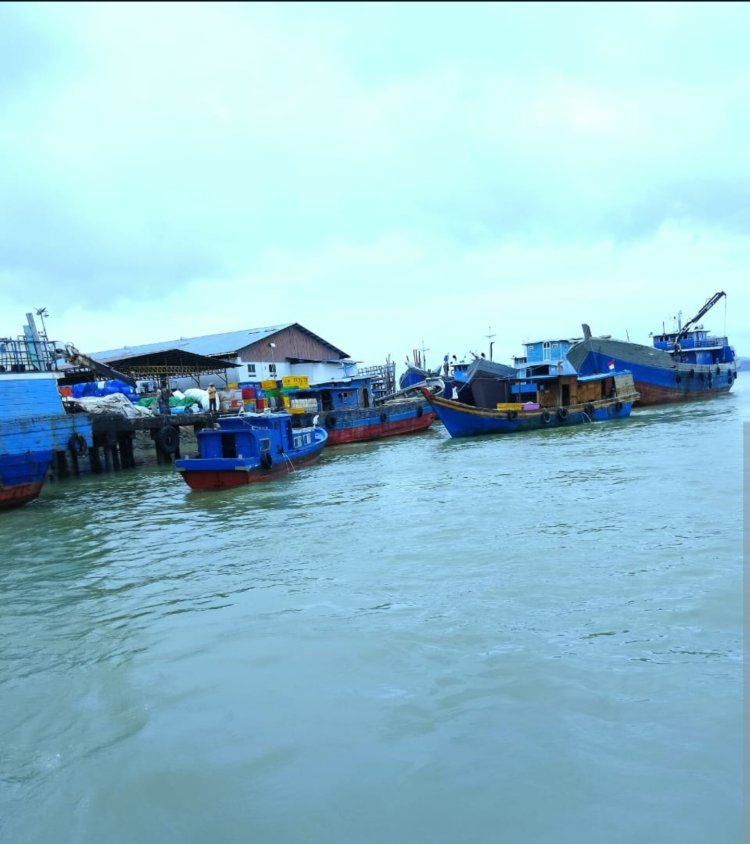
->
[0,322,93,509]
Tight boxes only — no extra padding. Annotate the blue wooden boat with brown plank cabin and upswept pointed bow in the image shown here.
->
[422,341,638,437]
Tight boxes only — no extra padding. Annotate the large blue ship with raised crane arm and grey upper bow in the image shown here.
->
[568,291,737,406]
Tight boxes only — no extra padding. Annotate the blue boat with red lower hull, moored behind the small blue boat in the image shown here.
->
[284,376,437,446]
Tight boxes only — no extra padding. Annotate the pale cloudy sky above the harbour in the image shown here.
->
[0,2,750,365]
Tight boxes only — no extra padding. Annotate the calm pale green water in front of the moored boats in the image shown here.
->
[0,382,750,844]
